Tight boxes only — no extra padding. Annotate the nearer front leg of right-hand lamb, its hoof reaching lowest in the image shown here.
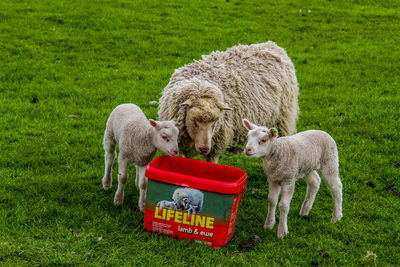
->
[278,182,294,238]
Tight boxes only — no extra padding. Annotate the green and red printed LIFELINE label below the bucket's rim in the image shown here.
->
[145,179,239,245]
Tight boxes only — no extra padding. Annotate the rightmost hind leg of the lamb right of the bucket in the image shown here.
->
[322,170,343,223]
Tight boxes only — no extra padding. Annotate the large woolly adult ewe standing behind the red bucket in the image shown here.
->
[158,41,299,163]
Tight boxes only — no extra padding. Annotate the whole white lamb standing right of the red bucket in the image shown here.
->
[243,119,343,238]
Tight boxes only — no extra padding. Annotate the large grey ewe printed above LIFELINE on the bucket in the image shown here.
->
[172,188,204,216]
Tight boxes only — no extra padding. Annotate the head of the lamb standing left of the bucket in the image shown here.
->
[149,119,179,156]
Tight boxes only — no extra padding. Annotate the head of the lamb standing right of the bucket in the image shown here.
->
[243,119,278,158]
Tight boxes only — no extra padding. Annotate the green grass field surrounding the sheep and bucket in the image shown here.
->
[0,0,400,266]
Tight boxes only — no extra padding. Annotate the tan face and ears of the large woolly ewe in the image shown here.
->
[180,97,232,155]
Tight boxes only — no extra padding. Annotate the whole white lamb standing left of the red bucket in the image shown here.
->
[102,104,179,211]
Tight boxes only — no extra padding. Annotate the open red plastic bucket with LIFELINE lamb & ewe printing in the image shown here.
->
[144,156,247,247]
